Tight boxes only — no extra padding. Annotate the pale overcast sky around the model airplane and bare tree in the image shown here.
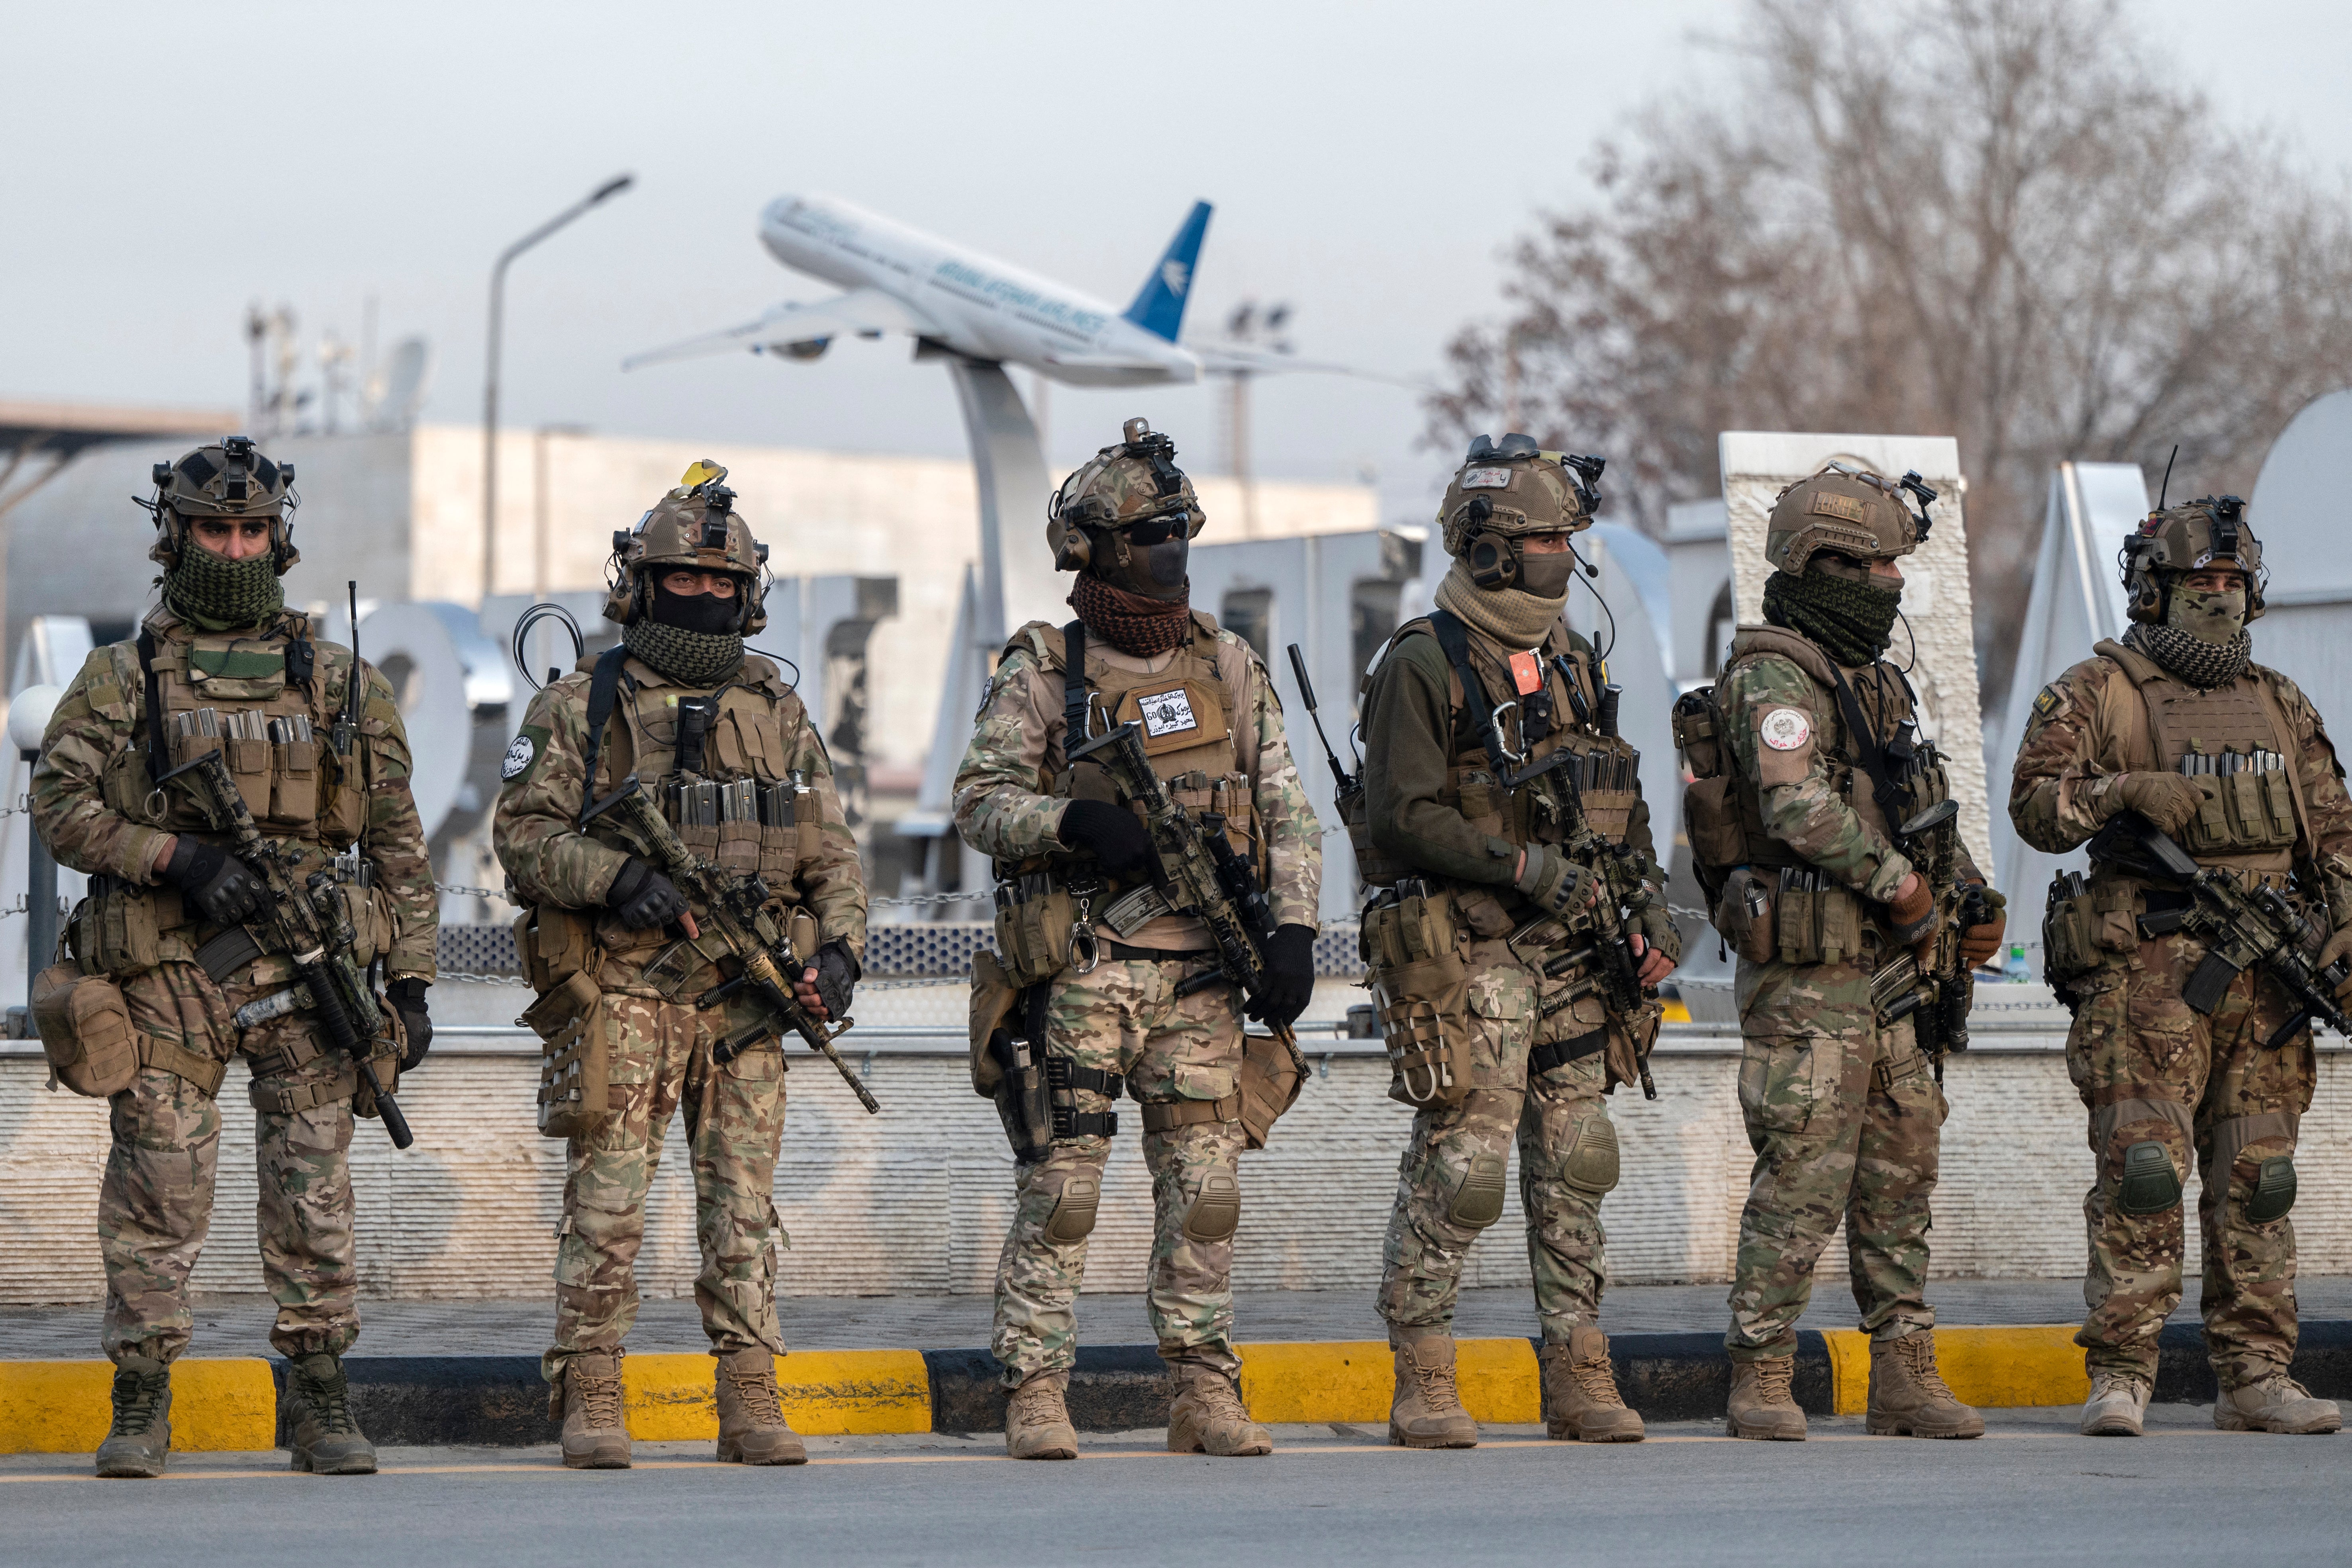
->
[0,0,2352,522]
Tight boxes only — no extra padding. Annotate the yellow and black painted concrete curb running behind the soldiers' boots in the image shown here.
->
[0,1319,2352,1453]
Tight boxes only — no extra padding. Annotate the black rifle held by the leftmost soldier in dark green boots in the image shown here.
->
[155,747,416,1150]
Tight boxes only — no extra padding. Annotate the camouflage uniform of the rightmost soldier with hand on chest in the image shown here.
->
[2009,642,2352,1390]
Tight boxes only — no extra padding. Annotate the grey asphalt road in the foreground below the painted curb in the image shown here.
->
[0,1406,2352,1568]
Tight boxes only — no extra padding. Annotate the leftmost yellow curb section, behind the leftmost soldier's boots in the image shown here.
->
[0,1356,278,1453]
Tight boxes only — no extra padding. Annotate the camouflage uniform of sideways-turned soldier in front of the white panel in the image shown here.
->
[1717,625,1978,1361]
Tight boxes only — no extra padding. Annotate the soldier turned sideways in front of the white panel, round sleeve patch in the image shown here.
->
[1677,463,2004,1441]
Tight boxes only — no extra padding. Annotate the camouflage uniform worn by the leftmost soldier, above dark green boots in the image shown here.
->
[33,609,440,1364]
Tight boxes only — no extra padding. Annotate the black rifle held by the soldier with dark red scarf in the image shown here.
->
[1068,719,1303,1053]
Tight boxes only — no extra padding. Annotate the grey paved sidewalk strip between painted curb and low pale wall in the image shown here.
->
[18,1276,2352,1359]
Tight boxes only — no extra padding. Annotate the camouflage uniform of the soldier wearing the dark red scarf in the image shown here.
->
[955,611,1322,1387]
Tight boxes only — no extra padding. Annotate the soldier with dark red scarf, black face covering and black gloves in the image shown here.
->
[955,418,1322,1460]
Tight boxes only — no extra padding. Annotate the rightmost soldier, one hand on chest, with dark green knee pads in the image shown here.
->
[2009,496,2352,1437]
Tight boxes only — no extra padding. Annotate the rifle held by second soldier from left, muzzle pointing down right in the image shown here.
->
[581,778,882,1114]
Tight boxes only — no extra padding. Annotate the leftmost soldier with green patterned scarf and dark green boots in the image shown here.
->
[33,435,440,1476]
